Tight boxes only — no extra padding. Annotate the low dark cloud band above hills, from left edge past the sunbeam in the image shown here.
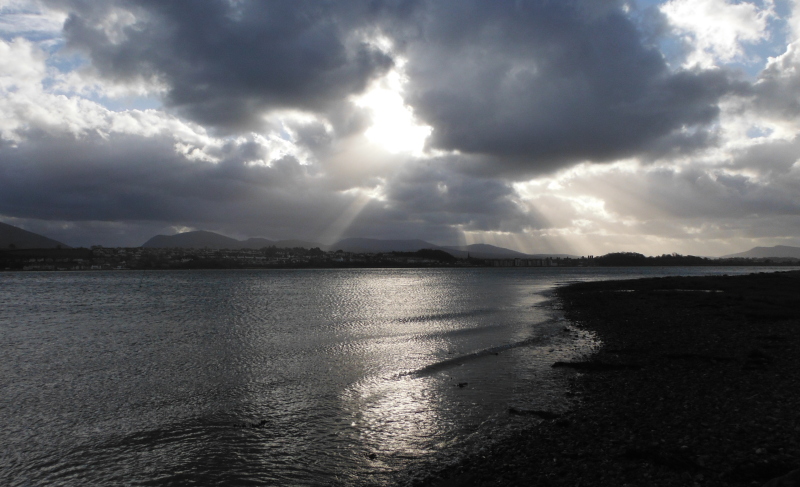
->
[0,131,527,246]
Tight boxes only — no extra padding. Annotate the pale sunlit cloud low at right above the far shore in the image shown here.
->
[519,154,800,255]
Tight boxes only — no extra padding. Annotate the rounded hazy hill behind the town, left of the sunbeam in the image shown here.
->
[142,230,320,250]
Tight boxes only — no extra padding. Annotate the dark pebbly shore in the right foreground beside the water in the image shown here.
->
[422,271,800,487]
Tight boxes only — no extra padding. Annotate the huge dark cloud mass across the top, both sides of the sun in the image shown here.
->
[47,0,742,172]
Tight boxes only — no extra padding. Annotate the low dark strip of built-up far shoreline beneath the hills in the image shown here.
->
[0,246,800,271]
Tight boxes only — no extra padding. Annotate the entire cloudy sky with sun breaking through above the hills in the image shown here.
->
[0,0,800,256]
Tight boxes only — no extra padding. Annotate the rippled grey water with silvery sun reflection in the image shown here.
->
[0,267,786,486]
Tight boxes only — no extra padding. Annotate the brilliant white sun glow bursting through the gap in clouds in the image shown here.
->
[353,64,433,154]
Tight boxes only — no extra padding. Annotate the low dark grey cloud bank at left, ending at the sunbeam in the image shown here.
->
[0,132,360,241]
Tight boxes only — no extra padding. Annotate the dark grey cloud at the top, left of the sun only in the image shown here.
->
[50,0,393,129]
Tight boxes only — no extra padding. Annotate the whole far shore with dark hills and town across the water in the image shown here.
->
[0,223,800,271]
